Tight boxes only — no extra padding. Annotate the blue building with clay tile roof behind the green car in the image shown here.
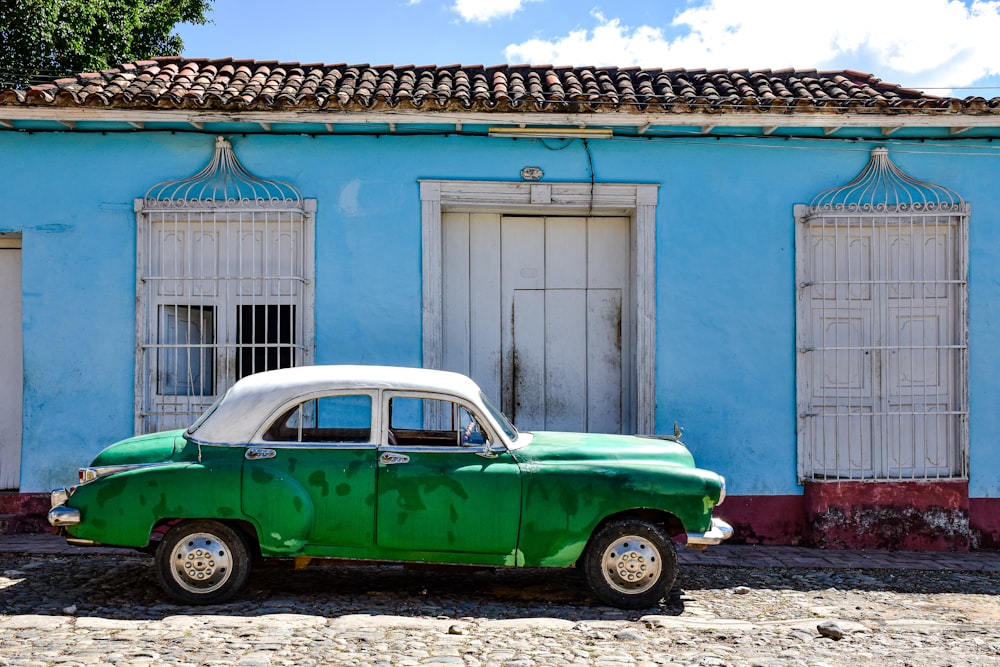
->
[0,58,1000,550]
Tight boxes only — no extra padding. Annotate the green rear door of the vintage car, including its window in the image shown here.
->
[243,391,378,555]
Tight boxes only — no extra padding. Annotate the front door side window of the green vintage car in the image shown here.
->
[389,396,486,447]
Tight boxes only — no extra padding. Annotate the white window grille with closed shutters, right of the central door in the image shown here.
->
[795,148,969,480]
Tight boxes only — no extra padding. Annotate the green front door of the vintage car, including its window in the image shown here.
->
[376,392,521,562]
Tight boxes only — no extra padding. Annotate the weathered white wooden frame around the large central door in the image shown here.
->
[418,179,659,433]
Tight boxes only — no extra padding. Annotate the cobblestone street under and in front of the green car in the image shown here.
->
[0,536,1000,667]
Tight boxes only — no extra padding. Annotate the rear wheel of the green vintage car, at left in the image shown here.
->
[156,521,250,604]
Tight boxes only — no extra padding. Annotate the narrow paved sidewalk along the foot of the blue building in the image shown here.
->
[0,533,1000,572]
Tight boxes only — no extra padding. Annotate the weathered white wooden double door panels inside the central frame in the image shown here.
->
[442,214,634,433]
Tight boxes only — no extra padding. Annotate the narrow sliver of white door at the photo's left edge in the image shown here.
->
[0,245,24,490]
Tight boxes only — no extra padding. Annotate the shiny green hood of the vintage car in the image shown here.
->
[515,431,694,467]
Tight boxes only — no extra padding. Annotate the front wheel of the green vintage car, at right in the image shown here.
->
[583,519,677,609]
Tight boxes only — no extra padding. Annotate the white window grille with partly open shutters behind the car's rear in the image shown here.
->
[135,137,316,433]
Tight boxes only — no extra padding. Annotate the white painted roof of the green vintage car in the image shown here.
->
[188,366,482,444]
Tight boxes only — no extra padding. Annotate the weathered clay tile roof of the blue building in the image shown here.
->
[0,56,1000,113]
